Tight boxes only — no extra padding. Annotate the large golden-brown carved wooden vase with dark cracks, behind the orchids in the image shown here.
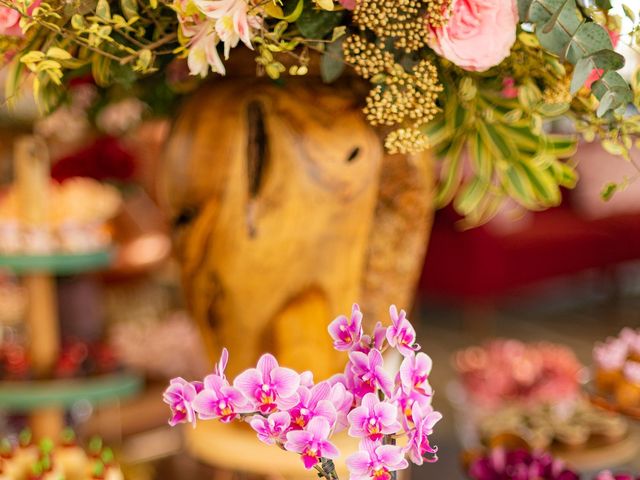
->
[162,78,433,378]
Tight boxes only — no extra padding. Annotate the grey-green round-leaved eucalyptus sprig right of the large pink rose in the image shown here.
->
[518,0,632,117]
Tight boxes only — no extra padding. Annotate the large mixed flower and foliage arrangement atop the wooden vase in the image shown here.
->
[0,0,640,224]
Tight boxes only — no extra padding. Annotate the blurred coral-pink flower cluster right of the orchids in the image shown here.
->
[454,339,582,410]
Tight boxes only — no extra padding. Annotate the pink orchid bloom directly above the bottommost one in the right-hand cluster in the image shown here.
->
[347,393,402,441]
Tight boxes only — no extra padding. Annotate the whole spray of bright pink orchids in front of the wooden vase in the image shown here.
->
[164,305,442,480]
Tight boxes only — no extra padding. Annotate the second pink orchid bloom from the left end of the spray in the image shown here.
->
[192,374,246,423]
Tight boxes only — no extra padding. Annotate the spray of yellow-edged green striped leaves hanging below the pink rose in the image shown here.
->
[423,77,577,227]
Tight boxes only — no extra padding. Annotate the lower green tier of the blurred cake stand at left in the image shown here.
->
[0,372,143,413]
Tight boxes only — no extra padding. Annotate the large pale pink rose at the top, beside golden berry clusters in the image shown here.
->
[429,0,518,72]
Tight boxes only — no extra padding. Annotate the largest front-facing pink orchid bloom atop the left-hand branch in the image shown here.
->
[233,353,300,414]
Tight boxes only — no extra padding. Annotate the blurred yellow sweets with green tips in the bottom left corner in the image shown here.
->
[0,430,124,480]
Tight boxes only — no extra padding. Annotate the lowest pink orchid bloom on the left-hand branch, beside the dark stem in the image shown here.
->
[284,417,340,470]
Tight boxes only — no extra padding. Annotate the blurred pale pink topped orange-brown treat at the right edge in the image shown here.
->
[593,328,640,410]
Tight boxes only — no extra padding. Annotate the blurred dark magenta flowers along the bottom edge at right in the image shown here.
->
[467,448,636,480]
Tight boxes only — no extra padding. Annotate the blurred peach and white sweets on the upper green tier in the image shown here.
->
[0,177,121,255]
